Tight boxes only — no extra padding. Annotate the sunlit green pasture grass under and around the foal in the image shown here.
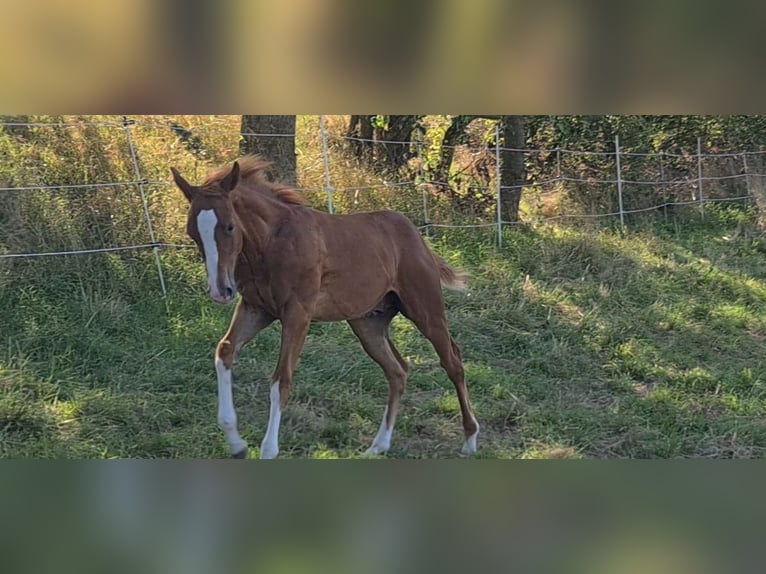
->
[0,205,766,458]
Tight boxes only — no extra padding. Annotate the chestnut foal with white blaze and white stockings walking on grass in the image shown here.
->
[171,155,479,459]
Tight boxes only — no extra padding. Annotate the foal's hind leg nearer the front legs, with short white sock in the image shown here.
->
[348,314,407,455]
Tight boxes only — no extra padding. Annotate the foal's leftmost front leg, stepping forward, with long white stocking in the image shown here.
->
[215,299,274,458]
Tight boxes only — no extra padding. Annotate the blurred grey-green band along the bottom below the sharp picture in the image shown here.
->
[0,461,764,574]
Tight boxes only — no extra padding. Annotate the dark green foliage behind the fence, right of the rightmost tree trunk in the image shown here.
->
[527,115,766,218]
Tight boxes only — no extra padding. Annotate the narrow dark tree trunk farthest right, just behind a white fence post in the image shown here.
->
[500,116,526,221]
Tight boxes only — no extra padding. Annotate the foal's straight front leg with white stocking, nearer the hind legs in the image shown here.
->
[261,306,311,459]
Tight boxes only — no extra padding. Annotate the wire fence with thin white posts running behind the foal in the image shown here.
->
[0,116,766,295]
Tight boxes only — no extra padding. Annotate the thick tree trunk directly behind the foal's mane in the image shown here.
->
[239,115,298,185]
